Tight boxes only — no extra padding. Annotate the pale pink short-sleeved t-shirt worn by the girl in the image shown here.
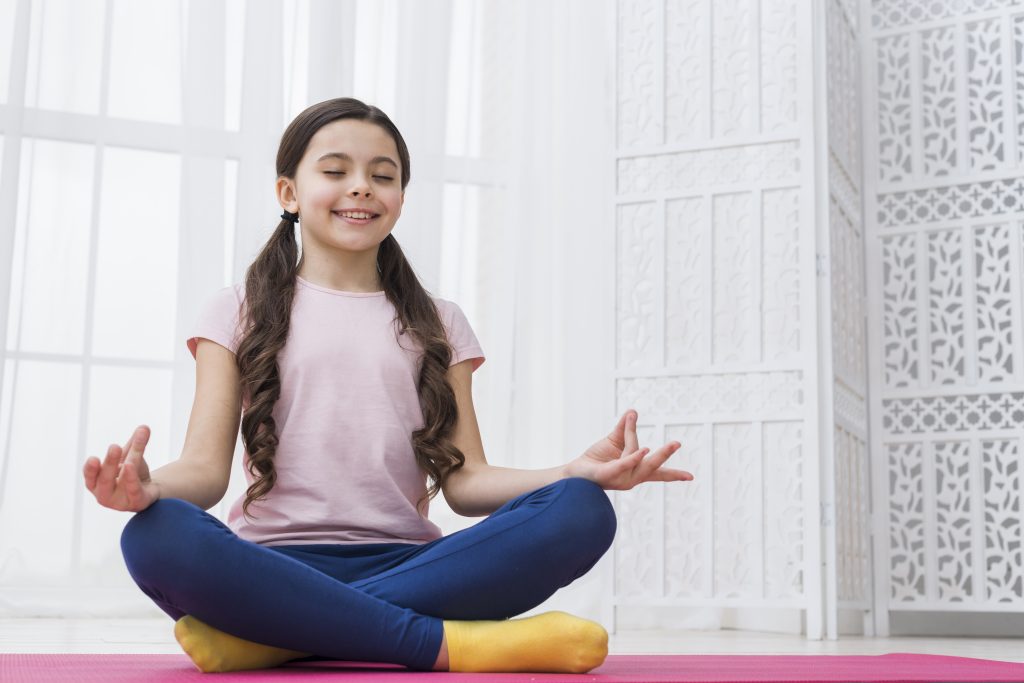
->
[186,276,484,546]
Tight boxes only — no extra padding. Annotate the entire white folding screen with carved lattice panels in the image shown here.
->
[613,0,1024,638]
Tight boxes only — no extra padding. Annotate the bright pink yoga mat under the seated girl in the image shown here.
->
[0,652,1024,683]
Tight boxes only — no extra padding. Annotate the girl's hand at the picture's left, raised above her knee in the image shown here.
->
[83,425,160,512]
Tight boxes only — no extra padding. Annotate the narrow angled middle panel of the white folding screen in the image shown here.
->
[815,0,873,635]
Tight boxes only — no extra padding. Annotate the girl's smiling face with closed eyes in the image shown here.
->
[278,119,406,252]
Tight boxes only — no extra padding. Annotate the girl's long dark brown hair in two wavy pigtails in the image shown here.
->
[236,97,466,515]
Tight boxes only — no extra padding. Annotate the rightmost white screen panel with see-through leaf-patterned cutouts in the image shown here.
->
[862,0,1024,633]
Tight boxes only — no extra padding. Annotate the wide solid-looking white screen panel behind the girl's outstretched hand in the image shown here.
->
[613,0,830,634]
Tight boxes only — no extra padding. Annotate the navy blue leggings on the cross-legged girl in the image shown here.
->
[121,477,616,671]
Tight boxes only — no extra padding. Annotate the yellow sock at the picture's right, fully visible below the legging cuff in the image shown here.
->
[443,611,608,674]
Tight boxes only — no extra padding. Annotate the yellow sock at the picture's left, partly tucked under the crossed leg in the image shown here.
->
[174,614,309,674]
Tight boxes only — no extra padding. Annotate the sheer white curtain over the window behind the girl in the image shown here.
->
[0,0,617,620]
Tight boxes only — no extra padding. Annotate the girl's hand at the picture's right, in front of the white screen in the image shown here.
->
[564,411,693,490]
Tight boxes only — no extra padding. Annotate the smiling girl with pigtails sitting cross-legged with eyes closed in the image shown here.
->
[84,97,692,673]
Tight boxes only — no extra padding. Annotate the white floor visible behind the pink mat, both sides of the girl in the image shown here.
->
[0,618,1024,663]
